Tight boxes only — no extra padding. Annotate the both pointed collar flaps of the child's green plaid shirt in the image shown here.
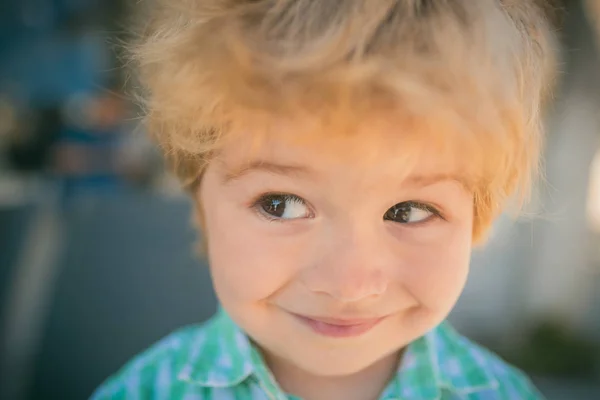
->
[179,309,499,400]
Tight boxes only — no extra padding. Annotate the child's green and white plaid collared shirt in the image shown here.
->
[92,311,543,400]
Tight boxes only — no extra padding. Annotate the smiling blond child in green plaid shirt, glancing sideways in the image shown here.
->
[93,0,553,400]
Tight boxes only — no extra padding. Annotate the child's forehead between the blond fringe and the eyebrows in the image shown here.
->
[219,117,473,185]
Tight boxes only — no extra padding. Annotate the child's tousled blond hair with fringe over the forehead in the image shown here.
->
[127,0,554,239]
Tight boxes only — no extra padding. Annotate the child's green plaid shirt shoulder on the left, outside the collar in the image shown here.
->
[91,322,212,400]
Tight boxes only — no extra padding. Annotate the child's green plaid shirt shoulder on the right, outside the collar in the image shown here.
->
[436,323,544,400]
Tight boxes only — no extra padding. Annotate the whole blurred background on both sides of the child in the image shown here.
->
[0,0,600,400]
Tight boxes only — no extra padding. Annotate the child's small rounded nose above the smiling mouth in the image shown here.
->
[302,225,393,303]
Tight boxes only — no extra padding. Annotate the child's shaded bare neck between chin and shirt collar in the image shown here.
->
[266,353,400,400]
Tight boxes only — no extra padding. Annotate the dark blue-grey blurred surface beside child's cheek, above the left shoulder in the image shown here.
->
[24,194,216,399]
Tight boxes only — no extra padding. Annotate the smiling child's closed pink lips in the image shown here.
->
[292,313,385,338]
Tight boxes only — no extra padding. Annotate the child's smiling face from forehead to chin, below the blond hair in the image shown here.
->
[199,123,473,375]
